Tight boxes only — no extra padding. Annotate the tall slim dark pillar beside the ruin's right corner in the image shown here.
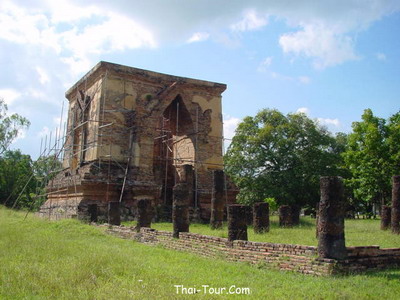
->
[210,170,225,229]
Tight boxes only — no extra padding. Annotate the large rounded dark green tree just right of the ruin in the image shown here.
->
[225,109,341,207]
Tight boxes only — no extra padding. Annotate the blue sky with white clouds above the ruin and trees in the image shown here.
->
[0,0,400,158]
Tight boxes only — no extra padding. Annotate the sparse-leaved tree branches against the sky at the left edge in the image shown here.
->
[0,98,30,156]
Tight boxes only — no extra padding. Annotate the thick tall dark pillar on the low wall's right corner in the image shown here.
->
[318,176,347,259]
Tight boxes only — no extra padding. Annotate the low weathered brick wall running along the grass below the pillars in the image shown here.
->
[107,226,400,276]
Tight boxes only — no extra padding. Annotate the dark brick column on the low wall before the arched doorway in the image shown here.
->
[172,183,190,238]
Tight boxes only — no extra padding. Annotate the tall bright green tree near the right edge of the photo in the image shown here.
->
[343,109,392,211]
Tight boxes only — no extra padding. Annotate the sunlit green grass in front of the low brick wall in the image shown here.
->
[0,207,400,299]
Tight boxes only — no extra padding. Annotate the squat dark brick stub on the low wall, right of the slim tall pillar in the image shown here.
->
[228,204,247,241]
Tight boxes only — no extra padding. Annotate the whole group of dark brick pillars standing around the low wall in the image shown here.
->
[108,172,400,259]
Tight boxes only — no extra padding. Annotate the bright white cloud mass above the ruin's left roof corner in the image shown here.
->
[0,1,156,76]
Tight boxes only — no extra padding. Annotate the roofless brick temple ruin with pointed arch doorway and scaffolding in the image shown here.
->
[40,62,237,221]
